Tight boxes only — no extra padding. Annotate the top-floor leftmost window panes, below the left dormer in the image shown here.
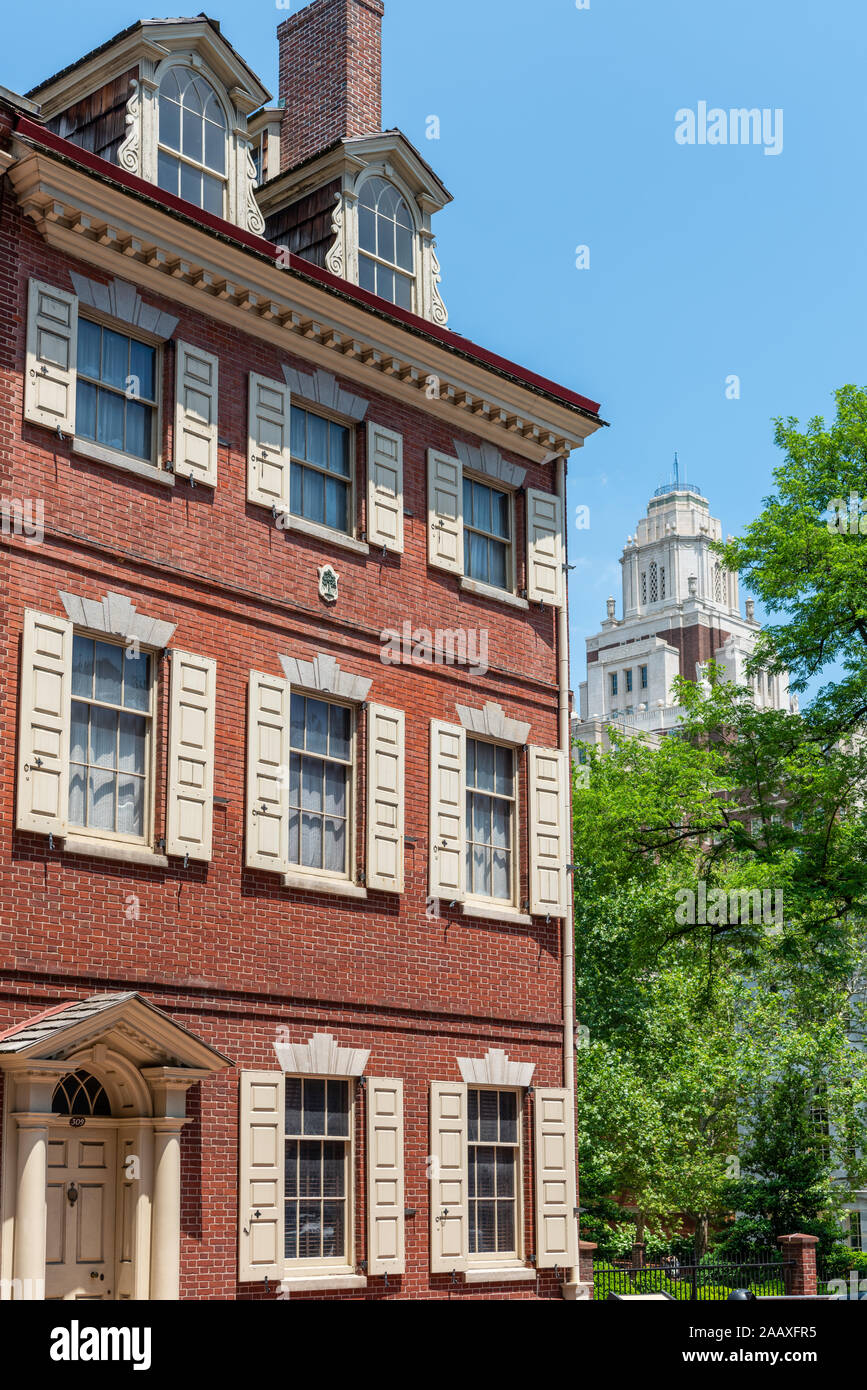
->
[75,318,157,463]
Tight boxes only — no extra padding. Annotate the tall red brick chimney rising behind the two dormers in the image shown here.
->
[276,0,385,170]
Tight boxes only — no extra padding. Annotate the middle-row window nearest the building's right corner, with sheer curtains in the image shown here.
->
[467,738,515,902]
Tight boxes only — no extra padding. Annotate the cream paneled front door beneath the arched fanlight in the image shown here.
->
[46,1119,117,1300]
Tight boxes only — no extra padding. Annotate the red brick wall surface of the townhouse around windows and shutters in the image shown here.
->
[0,202,563,1298]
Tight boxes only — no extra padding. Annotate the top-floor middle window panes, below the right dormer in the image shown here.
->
[290,406,353,534]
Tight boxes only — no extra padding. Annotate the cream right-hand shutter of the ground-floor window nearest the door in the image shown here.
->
[367,1076,406,1275]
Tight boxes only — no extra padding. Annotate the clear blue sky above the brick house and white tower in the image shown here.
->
[0,0,867,695]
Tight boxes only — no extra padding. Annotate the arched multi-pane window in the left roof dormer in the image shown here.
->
[157,68,226,217]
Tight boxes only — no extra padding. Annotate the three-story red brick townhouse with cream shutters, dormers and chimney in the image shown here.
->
[0,0,600,1300]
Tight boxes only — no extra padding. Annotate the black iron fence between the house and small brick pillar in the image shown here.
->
[593,1252,785,1302]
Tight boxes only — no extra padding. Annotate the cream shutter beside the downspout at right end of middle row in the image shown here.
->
[528,748,571,917]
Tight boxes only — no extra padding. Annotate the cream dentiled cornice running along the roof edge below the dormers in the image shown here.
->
[10,149,600,463]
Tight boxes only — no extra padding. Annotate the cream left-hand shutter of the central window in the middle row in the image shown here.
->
[246,671,290,873]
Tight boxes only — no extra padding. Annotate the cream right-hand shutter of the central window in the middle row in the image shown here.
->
[367,705,406,892]
